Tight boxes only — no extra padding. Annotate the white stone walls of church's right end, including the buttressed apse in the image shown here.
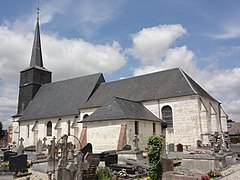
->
[143,95,227,148]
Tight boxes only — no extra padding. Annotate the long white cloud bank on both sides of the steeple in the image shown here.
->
[0,20,126,128]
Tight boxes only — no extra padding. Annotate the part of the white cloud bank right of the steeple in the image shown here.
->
[42,35,126,79]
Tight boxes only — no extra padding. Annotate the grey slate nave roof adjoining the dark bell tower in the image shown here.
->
[19,73,105,121]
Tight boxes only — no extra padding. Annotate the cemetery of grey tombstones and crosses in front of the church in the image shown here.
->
[0,131,239,180]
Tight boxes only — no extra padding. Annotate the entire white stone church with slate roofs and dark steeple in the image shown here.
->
[12,19,227,152]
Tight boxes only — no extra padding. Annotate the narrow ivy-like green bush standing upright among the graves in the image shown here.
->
[147,135,165,180]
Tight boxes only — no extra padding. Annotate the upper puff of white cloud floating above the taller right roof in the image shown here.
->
[129,24,187,65]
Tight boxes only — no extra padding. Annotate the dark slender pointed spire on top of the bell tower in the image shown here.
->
[30,18,43,67]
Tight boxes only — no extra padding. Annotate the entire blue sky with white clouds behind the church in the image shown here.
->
[0,0,240,127]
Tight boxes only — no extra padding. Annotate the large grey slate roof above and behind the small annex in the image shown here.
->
[80,68,216,109]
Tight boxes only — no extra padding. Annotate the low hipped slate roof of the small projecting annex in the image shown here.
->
[81,97,163,122]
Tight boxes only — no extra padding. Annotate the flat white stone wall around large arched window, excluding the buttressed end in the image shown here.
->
[143,96,200,148]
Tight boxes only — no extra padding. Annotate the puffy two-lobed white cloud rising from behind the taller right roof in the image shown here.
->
[128,24,195,75]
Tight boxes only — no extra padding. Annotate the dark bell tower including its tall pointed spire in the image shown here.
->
[17,8,52,116]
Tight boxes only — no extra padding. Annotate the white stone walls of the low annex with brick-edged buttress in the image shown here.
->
[86,120,161,153]
